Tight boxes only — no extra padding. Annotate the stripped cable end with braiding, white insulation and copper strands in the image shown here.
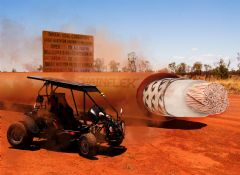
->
[142,78,228,117]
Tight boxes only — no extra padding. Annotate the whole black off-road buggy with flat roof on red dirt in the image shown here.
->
[7,76,125,157]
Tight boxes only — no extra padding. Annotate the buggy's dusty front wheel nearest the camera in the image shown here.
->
[79,133,97,157]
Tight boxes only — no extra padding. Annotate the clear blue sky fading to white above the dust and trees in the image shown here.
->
[0,0,240,71]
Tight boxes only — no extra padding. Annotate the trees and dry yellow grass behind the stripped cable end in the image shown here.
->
[168,59,240,95]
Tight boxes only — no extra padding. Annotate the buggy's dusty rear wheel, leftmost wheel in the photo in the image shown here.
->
[7,122,33,149]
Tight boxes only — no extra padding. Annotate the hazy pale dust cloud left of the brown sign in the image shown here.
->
[0,19,42,71]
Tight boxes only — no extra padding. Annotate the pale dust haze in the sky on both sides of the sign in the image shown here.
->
[0,19,144,72]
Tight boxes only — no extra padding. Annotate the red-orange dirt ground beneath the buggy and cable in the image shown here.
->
[0,96,240,175]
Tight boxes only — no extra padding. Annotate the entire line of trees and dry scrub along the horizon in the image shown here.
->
[3,52,240,95]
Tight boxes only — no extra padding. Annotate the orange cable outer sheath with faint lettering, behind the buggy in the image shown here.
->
[0,73,156,121]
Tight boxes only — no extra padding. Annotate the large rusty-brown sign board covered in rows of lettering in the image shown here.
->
[42,31,94,72]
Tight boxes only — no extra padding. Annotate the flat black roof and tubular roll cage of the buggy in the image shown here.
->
[27,76,119,123]
